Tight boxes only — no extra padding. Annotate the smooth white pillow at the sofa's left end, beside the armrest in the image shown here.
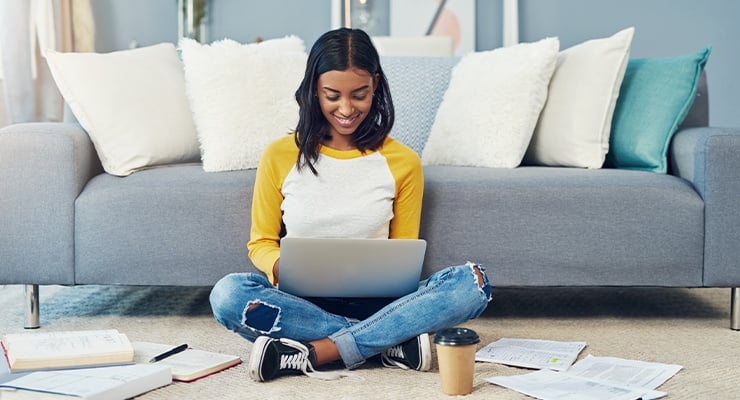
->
[46,43,199,176]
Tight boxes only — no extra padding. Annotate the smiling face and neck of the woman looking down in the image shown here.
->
[318,68,376,150]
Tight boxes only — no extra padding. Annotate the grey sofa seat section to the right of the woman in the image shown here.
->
[421,166,704,286]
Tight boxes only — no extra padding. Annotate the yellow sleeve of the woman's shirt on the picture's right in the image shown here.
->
[381,138,424,239]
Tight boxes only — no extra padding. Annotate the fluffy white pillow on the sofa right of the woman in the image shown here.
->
[422,38,559,168]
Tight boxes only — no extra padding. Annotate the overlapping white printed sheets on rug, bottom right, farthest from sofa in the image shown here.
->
[486,355,682,400]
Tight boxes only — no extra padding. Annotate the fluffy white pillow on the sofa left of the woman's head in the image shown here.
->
[180,36,307,171]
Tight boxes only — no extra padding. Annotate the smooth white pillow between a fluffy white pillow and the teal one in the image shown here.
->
[524,28,634,168]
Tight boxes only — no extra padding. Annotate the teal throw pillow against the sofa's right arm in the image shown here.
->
[606,47,711,173]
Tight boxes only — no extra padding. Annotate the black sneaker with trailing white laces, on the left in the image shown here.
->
[249,336,344,382]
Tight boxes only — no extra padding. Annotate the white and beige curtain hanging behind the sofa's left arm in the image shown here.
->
[0,0,95,126]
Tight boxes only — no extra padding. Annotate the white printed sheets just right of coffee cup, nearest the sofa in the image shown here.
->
[475,338,586,371]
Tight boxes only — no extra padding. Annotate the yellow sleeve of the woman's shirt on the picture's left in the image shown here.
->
[247,135,298,283]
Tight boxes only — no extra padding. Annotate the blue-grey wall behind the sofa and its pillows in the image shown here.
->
[92,0,740,126]
